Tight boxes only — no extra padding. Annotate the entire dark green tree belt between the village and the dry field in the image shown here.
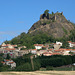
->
[0,54,75,71]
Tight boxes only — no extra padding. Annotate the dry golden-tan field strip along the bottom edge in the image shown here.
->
[0,71,75,75]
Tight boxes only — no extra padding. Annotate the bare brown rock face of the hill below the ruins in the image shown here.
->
[28,13,74,38]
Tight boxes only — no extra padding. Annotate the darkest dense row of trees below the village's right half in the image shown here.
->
[39,55,74,68]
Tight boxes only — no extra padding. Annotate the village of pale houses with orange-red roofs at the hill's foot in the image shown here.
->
[0,41,75,68]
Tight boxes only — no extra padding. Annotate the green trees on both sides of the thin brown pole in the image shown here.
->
[13,54,40,71]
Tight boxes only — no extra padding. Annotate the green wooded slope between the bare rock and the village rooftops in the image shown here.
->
[5,27,75,49]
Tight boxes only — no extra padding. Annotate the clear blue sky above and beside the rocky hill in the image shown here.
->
[0,0,75,44]
